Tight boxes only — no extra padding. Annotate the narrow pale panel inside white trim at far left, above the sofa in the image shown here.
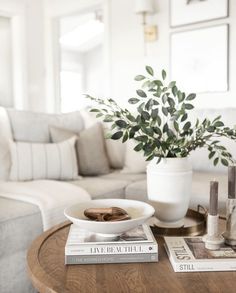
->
[0,17,13,107]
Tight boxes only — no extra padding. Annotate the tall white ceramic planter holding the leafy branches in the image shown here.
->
[147,158,192,227]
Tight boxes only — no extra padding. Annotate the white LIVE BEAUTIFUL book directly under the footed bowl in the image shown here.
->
[65,225,158,255]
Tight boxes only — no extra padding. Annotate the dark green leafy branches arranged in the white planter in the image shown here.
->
[87,66,236,166]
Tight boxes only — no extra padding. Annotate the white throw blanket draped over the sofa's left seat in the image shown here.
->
[0,180,91,231]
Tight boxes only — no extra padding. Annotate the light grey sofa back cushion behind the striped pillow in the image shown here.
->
[7,109,84,142]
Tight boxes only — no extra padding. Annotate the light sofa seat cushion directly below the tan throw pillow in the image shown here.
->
[71,176,133,199]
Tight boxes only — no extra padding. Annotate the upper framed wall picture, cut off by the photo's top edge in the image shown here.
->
[169,0,229,27]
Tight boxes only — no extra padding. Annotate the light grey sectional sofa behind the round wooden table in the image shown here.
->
[0,107,236,293]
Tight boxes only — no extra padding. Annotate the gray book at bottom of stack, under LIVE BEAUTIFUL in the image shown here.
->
[65,253,158,265]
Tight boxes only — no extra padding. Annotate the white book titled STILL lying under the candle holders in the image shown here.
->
[164,237,236,272]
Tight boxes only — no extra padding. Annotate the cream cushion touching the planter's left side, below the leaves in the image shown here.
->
[121,140,148,173]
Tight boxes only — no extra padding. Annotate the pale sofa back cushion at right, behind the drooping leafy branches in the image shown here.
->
[190,108,236,172]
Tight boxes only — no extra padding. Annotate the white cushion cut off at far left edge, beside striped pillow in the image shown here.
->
[0,107,12,180]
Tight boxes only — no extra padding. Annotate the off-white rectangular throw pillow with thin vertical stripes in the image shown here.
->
[10,137,78,181]
